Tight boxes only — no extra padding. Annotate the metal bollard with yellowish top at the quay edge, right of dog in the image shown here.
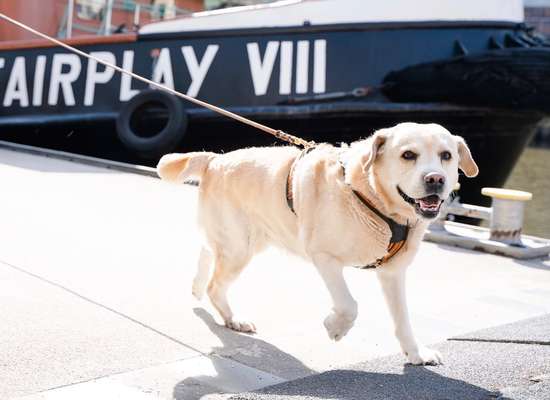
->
[481,188,533,246]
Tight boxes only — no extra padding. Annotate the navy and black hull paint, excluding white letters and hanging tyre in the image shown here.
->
[0,21,550,202]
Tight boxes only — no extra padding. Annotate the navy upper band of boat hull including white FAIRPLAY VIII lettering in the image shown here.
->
[0,21,544,124]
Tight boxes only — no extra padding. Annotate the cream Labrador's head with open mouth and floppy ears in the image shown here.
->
[362,122,478,219]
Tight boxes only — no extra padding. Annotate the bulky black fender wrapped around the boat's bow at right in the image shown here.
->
[384,47,550,113]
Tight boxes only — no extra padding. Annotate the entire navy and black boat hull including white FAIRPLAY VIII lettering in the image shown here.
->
[0,21,550,203]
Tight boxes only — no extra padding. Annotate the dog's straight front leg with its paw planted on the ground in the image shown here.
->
[376,263,442,365]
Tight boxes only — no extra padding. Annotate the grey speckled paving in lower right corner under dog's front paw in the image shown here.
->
[230,315,550,400]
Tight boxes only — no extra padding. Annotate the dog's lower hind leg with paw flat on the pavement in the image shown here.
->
[208,254,256,332]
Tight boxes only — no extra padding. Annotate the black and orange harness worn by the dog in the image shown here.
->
[286,147,409,269]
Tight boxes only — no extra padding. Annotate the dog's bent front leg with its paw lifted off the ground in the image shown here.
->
[313,253,357,341]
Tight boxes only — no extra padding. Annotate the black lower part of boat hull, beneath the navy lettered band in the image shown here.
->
[0,102,543,205]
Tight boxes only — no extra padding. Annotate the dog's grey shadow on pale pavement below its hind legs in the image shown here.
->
[173,308,317,400]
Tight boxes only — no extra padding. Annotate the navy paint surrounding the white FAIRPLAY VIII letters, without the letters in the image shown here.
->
[0,23,536,119]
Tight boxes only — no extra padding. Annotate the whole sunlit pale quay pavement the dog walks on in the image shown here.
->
[0,150,550,400]
